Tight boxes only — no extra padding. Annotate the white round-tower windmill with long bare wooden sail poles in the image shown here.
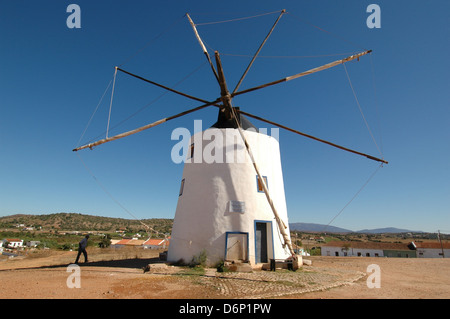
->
[73,10,387,264]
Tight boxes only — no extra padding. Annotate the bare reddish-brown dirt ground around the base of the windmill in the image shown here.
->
[0,249,450,299]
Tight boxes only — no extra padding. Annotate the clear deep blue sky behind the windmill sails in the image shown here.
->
[0,0,450,233]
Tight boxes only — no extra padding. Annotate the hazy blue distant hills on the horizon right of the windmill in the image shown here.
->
[289,223,422,234]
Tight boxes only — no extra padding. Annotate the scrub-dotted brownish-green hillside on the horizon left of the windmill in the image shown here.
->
[0,213,173,233]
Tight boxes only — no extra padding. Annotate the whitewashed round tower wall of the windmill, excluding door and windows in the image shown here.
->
[168,129,290,264]
